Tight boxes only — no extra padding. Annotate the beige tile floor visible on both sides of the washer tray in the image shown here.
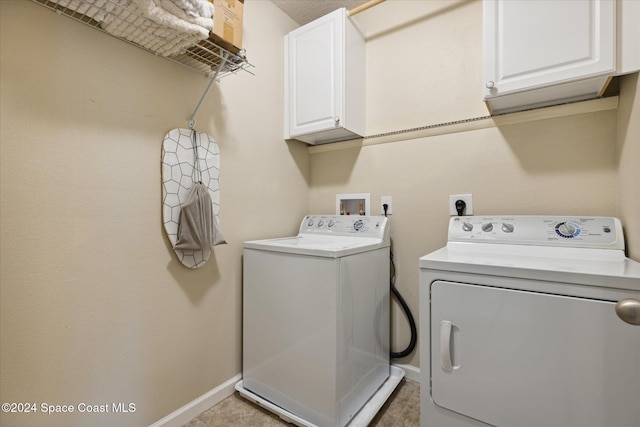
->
[183,379,420,427]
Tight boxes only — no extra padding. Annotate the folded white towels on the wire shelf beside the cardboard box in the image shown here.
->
[101,0,213,56]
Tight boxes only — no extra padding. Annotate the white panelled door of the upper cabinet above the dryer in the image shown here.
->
[483,0,615,97]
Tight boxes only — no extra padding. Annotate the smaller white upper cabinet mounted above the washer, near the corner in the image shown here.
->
[284,8,365,144]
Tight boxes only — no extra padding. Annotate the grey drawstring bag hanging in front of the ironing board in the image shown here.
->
[173,131,226,251]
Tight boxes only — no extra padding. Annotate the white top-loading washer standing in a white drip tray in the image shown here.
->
[236,215,404,427]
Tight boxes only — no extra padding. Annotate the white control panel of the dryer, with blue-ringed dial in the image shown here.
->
[449,215,624,249]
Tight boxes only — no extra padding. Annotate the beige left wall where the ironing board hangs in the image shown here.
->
[0,0,309,427]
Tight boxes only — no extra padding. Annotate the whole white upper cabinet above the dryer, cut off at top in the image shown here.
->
[483,0,640,113]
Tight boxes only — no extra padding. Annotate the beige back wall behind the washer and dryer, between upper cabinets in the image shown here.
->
[310,1,640,366]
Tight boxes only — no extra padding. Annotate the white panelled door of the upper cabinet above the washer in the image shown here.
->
[285,10,344,136]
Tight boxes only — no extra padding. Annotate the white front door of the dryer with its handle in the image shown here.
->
[431,281,640,427]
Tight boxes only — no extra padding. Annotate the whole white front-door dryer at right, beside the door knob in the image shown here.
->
[420,216,640,427]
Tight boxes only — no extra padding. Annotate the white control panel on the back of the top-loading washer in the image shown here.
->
[300,215,388,239]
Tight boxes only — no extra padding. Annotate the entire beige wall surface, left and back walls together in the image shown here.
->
[0,0,640,426]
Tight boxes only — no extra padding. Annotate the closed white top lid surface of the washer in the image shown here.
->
[244,234,385,258]
